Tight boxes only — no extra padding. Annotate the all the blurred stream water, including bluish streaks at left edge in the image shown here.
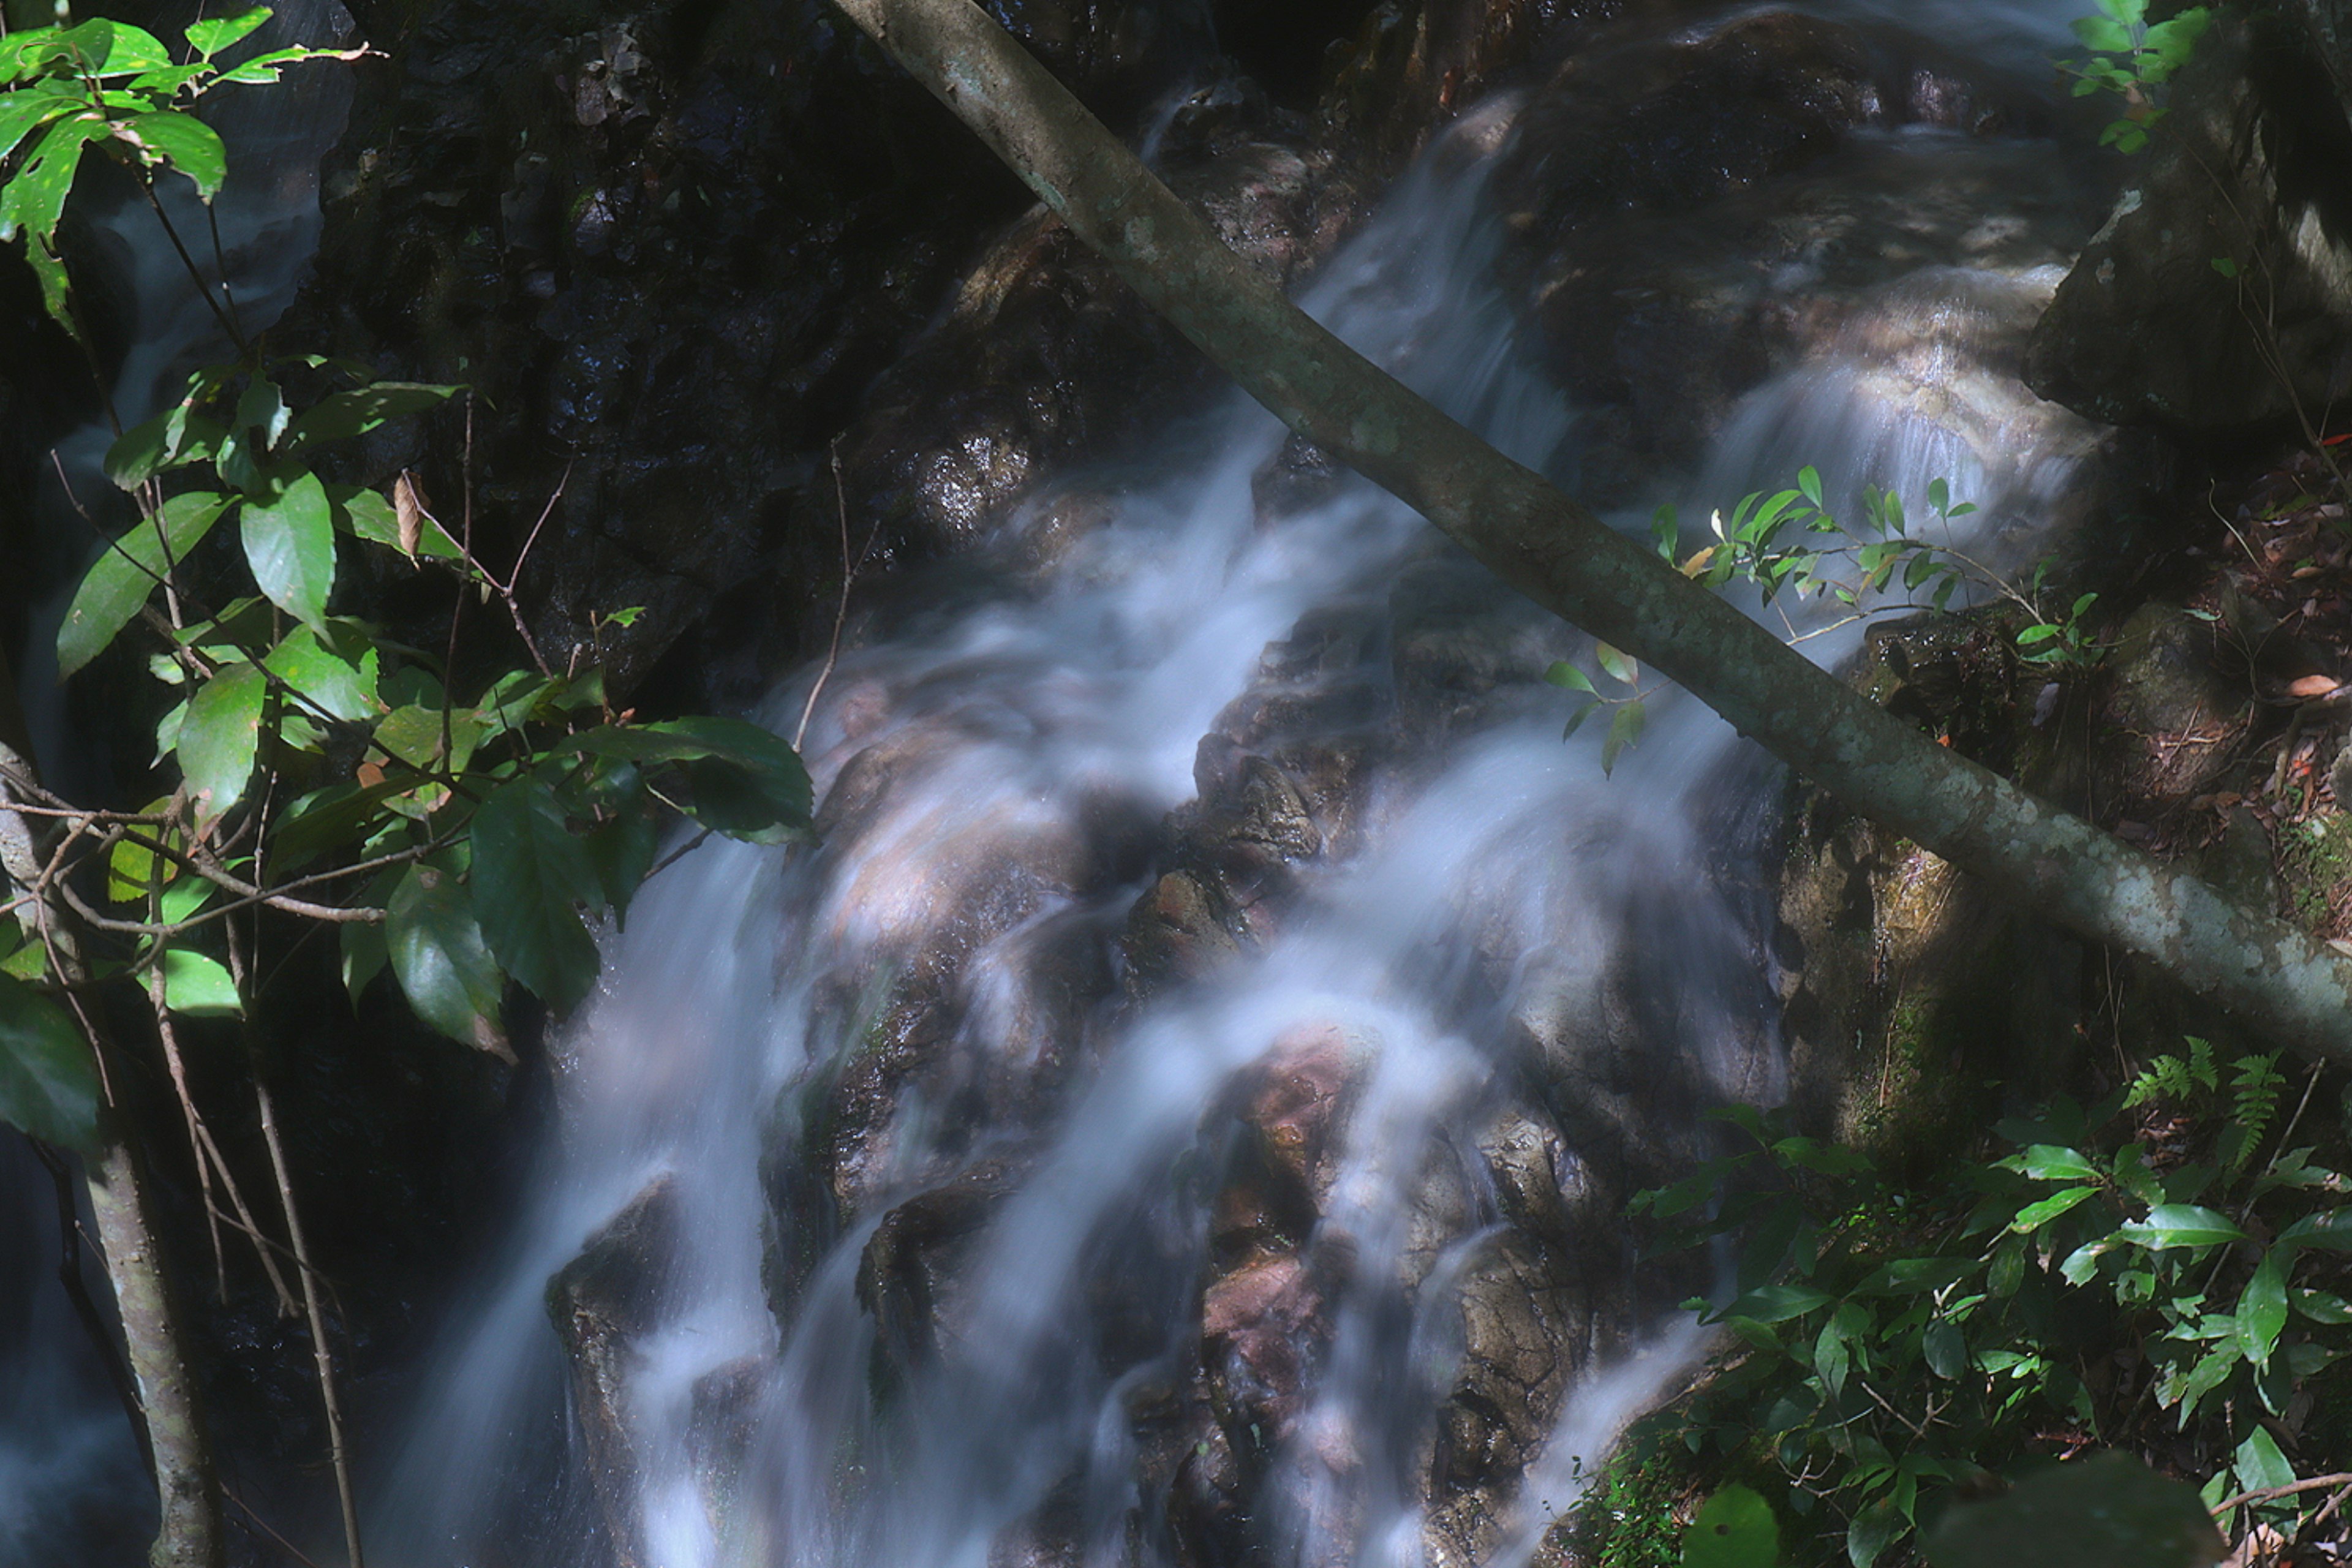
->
[0,0,2117,1568]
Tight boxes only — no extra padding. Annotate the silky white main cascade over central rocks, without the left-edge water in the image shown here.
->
[372,7,2117,1568]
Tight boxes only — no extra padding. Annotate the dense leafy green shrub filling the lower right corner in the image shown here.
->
[1635,1086,2352,1568]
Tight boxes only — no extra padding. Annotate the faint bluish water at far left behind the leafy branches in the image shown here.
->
[0,0,350,1568]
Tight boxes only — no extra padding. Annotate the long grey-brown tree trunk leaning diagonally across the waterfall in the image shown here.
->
[837,0,2352,1065]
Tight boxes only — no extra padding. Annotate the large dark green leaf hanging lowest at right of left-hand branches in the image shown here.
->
[473,778,605,1011]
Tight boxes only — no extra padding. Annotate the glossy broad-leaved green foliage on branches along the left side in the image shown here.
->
[0,9,809,1147]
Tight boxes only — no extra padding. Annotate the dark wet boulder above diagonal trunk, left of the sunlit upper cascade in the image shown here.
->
[1493,12,2084,503]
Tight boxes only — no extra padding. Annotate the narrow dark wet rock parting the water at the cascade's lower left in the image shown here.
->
[548,1175,680,1568]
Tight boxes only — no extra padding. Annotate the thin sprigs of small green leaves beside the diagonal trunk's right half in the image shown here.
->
[1543,479,2100,774]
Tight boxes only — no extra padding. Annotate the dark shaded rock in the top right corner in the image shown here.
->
[2025,15,2352,437]
